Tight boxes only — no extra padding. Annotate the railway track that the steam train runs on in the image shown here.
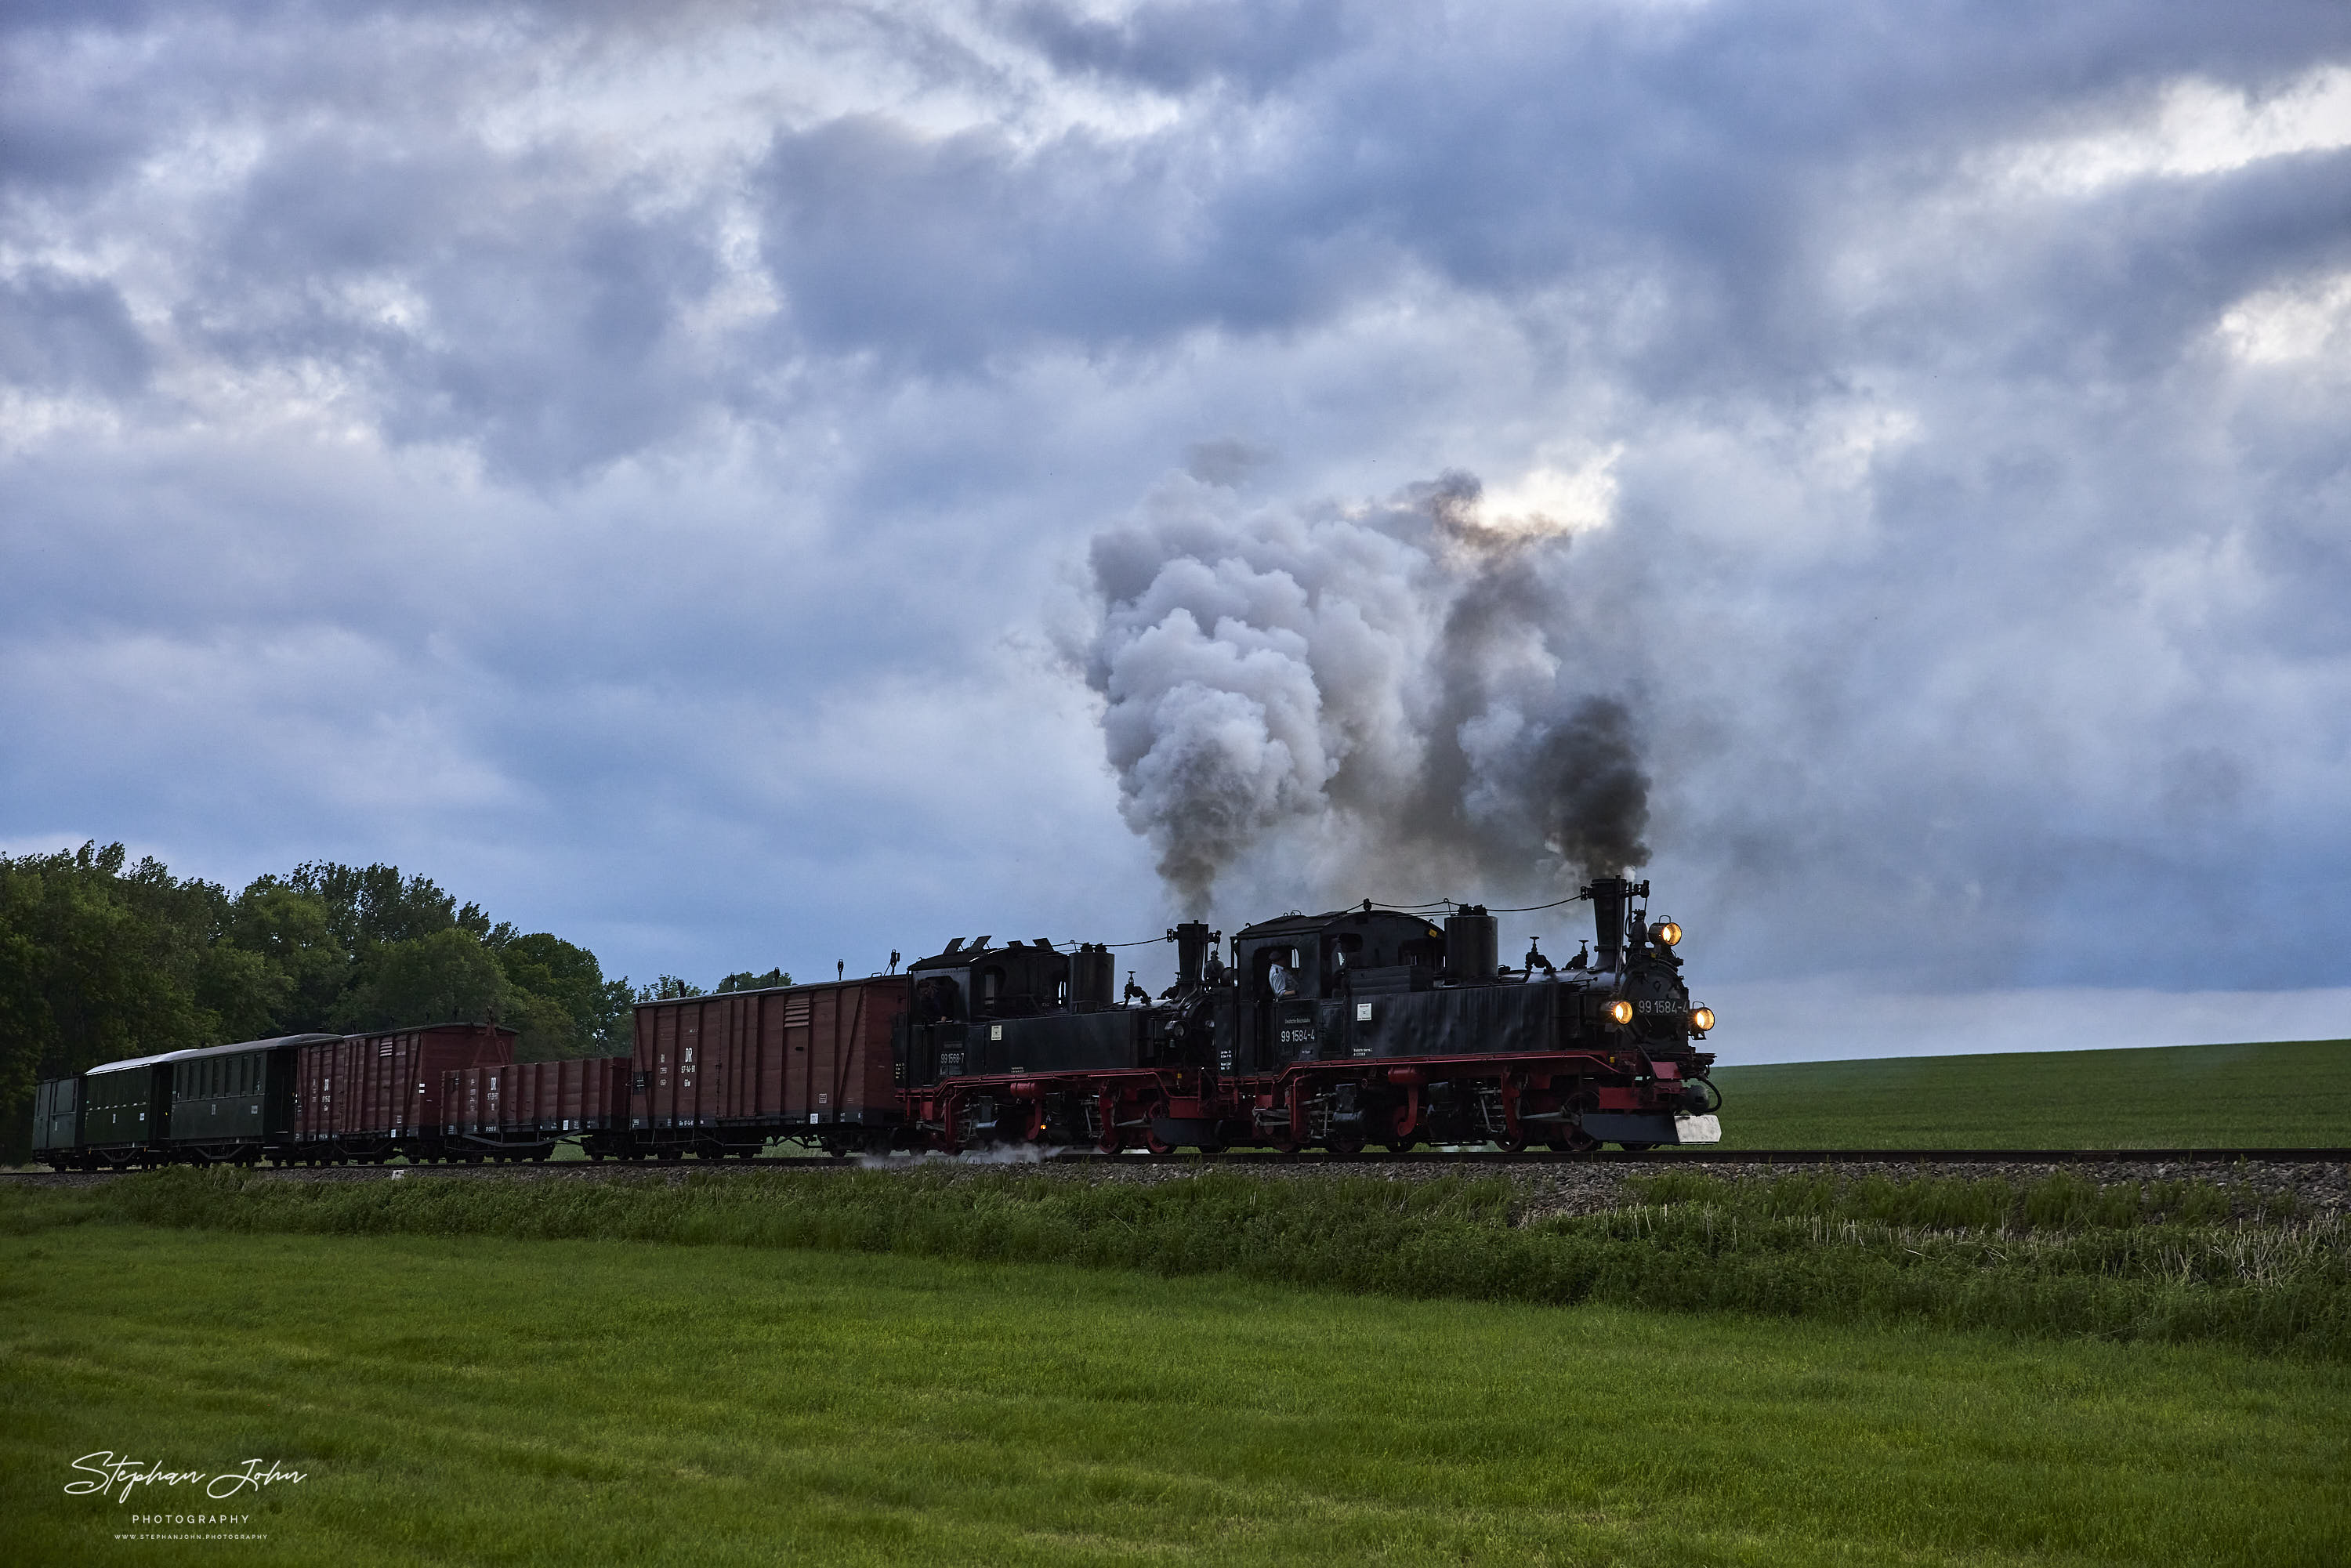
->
[0,1147,2351,1180]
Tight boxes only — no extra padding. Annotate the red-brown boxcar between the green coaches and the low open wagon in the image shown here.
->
[294,1023,515,1159]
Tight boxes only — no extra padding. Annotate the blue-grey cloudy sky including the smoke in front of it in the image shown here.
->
[0,0,2351,1060]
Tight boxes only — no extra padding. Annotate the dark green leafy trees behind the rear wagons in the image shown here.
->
[0,842,792,1164]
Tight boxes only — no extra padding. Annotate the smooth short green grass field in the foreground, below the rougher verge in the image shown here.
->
[13,1225,2351,1568]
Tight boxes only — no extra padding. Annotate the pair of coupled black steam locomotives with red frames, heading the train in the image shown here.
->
[898,877,1721,1154]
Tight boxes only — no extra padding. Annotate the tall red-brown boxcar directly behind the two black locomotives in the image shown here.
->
[630,976,907,1152]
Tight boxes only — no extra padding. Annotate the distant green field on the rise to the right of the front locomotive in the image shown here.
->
[1714,1039,2351,1150]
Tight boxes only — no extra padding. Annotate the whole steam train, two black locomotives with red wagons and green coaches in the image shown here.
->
[33,877,1721,1168]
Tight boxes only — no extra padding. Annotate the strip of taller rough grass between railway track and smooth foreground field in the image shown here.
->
[0,1166,2351,1363]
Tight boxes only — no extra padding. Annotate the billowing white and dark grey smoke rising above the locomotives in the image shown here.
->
[1086,473,1648,914]
